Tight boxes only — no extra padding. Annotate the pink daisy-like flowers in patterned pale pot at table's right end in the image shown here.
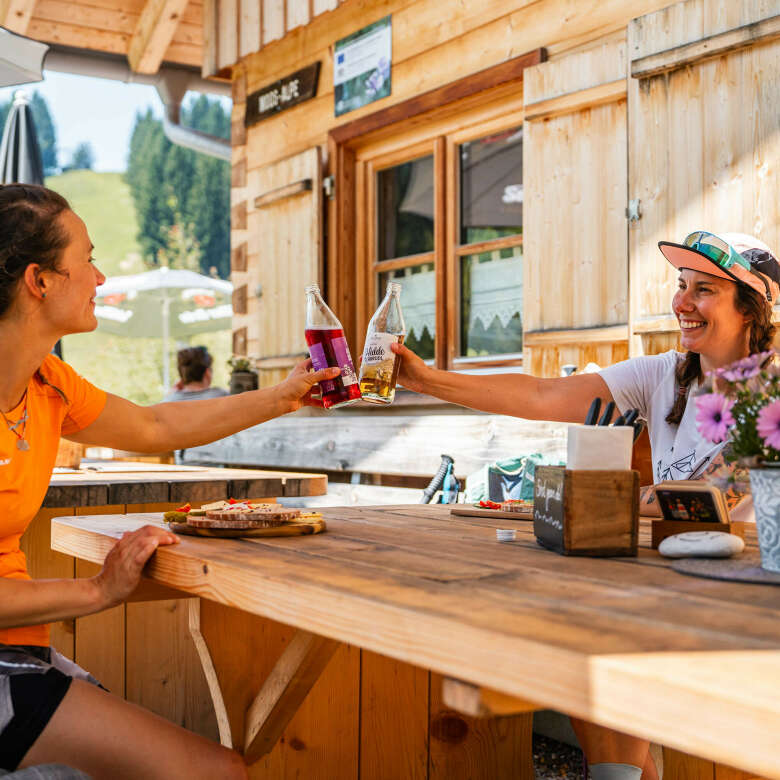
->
[696,350,780,572]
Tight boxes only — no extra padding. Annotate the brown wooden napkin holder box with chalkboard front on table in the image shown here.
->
[534,466,639,557]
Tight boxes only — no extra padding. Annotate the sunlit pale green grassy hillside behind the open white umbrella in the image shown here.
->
[46,171,230,404]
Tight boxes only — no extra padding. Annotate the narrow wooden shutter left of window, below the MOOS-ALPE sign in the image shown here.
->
[238,147,322,385]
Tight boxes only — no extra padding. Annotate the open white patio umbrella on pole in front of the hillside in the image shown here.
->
[95,266,233,392]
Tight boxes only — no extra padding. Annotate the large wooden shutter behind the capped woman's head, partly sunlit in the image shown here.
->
[629,0,780,354]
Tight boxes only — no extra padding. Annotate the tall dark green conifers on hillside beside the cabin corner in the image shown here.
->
[126,96,230,278]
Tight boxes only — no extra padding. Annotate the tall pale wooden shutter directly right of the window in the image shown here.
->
[523,36,628,376]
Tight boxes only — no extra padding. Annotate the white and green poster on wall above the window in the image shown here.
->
[333,16,393,116]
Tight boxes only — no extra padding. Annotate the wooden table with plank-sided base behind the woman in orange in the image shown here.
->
[21,461,327,735]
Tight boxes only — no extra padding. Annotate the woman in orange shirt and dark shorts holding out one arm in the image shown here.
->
[0,184,338,780]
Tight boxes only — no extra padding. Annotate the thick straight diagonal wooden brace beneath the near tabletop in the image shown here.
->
[244,630,340,764]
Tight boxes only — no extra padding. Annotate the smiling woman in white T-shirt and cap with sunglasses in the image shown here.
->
[393,231,780,780]
